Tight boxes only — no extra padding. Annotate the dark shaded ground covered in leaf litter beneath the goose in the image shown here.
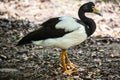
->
[0,19,120,80]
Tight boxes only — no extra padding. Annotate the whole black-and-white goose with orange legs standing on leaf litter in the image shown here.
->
[17,2,102,75]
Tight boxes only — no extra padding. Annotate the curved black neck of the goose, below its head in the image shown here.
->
[78,9,96,36]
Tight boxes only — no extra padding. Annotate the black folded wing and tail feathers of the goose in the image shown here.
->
[17,17,69,45]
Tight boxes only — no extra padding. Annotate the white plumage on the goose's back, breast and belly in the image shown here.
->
[33,17,87,49]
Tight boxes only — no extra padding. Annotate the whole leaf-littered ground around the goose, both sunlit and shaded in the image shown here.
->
[0,0,120,80]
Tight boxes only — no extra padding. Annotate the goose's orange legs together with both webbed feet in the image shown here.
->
[61,50,77,75]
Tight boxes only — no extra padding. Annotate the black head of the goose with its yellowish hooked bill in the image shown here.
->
[81,2,102,16]
